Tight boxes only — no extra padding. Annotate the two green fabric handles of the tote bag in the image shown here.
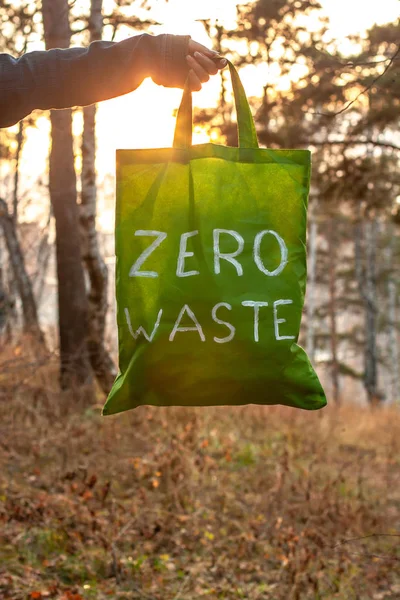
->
[174,60,258,148]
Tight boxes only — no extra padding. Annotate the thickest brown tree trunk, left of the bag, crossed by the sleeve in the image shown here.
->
[42,0,91,388]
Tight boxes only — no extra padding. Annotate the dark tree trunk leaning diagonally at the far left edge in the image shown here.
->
[0,198,44,344]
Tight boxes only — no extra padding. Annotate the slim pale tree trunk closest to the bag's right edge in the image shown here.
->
[306,202,317,362]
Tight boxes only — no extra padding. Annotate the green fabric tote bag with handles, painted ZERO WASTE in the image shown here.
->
[103,64,326,415]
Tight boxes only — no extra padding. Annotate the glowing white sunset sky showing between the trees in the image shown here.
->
[0,0,400,231]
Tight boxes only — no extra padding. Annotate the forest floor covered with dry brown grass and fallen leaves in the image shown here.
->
[0,354,400,600]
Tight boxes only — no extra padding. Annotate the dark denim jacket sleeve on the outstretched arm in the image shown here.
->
[0,34,190,127]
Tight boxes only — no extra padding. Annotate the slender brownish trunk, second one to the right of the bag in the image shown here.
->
[328,217,340,404]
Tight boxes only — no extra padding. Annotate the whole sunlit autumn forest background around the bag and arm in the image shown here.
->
[0,0,400,599]
